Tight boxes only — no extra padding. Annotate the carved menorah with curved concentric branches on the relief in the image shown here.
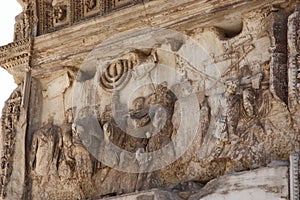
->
[100,59,132,92]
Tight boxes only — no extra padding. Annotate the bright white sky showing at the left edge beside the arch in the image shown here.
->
[0,0,22,112]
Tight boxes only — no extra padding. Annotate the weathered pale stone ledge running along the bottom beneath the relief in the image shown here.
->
[94,166,289,200]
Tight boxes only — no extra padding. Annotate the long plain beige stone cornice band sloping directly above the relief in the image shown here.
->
[32,0,290,74]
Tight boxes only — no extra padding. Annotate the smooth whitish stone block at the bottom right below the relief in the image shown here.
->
[189,166,289,200]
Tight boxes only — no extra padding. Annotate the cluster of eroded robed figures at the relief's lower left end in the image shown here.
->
[30,109,94,199]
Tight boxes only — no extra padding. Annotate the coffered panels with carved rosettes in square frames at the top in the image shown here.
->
[37,0,142,35]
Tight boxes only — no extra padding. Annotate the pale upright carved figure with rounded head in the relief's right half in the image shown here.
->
[214,80,240,142]
